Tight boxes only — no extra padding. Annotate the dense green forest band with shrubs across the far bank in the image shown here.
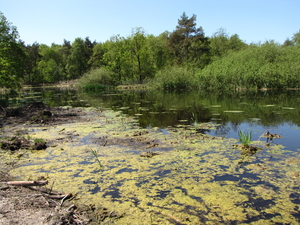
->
[0,12,300,89]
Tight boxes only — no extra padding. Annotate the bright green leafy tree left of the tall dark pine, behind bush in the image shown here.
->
[102,28,166,84]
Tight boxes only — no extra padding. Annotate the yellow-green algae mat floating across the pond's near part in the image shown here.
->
[2,108,300,225]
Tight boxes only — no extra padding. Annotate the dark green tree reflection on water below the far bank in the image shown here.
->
[78,91,300,128]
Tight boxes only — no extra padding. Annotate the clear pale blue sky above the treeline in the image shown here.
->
[0,0,300,45]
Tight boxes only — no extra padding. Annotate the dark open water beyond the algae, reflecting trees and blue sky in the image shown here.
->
[29,89,300,151]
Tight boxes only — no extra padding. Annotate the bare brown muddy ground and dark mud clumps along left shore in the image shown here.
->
[0,102,121,224]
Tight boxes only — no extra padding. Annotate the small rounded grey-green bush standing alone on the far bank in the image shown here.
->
[77,68,115,89]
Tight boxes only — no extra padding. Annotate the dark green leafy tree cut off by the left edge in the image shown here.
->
[0,12,26,88]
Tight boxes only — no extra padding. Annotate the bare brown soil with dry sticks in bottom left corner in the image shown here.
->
[0,172,120,225]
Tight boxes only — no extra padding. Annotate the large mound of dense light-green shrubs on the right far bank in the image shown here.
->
[196,43,300,89]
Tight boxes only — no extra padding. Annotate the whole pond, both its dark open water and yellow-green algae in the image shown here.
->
[5,89,300,224]
